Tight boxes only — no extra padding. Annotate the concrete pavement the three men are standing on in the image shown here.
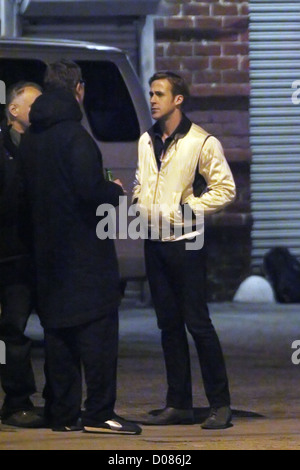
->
[0,300,300,455]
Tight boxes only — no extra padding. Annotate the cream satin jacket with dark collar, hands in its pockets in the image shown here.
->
[133,120,236,241]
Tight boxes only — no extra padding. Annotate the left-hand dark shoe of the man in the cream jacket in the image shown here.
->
[139,407,195,426]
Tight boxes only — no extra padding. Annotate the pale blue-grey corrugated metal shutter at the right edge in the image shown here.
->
[249,0,300,268]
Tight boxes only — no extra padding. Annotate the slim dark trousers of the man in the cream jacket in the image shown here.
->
[145,240,230,409]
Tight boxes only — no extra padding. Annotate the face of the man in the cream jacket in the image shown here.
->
[150,79,182,121]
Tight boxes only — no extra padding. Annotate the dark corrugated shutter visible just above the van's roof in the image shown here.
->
[23,16,141,72]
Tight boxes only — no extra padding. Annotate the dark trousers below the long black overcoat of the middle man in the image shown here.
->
[44,310,118,426]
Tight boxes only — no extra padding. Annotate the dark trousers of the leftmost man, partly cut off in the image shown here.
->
[0,284,36,417]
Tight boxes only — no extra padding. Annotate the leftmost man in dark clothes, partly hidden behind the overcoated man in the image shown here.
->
[0,82,43,428]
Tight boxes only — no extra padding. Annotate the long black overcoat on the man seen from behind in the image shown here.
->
[20,90,123,328]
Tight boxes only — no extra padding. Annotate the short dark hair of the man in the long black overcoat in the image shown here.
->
[44,59,82,93]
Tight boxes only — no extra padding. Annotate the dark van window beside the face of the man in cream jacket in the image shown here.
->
[78,62,140,142]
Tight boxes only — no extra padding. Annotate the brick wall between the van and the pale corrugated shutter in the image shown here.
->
[155,0,251,300]
